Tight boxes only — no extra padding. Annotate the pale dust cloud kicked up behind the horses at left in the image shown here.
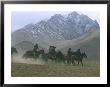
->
[11,56,45,65]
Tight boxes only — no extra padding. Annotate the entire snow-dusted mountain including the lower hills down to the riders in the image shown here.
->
[11,12,100,57]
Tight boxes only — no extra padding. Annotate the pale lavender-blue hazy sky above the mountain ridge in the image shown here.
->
[11,11,100,32]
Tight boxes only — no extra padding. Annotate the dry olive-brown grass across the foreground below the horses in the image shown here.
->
[11,60,100,77]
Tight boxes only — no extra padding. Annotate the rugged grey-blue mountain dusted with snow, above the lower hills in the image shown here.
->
[11,12,100,46]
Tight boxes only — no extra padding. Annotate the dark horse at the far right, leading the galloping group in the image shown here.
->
[72,52,87,66]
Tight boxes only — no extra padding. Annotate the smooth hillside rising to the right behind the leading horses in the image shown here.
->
[58,31,100,59]
